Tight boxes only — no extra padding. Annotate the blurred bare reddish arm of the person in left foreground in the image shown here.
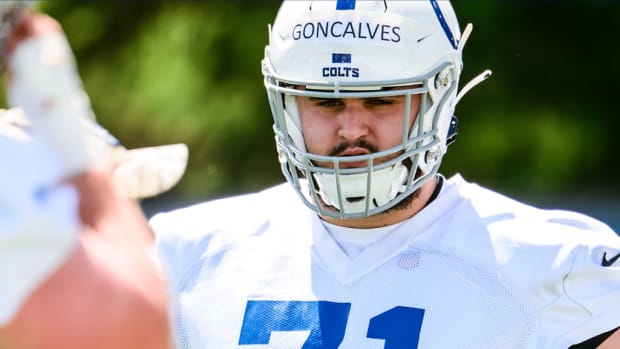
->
[0,165,170,349]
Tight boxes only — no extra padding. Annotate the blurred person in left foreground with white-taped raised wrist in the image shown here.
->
[0,2,184,349]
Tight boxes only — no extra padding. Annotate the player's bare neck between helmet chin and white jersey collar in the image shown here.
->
[321,177,437,229]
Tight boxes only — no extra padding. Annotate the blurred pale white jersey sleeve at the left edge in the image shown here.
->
[0,135,79,326]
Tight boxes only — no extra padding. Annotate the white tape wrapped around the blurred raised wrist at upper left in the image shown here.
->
[8,33,95,177]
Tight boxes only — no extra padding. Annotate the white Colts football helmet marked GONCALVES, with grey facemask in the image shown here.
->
[262,0,490,219]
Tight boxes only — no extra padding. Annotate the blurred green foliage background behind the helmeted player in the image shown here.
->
[27,0,620,204]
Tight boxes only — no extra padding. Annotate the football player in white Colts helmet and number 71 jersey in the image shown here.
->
[151,0,620,349]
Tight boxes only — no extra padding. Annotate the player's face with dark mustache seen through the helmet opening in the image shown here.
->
[297,88,420,167]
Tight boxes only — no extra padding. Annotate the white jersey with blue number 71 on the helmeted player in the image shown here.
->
[151,175,620,349]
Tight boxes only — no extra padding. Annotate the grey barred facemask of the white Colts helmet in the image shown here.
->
[266,67,455,219]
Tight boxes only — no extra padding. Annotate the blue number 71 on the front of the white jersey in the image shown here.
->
[239,301,424,349]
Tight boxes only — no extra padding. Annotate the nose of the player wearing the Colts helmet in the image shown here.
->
[338,100,371,142]
